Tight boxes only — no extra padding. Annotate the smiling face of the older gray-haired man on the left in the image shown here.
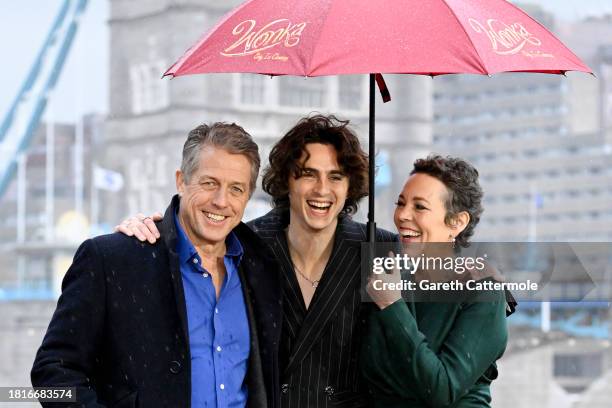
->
[176,146,251,247]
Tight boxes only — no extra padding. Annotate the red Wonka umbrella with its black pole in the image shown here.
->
[164,0,591,239]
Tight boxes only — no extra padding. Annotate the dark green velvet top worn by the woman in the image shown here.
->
[361,292,507,408]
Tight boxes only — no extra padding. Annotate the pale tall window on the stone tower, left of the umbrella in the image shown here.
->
[130,61,169,115]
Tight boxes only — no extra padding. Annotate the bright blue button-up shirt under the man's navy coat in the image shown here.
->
[174,210,250,408]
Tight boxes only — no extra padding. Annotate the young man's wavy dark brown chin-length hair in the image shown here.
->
[262,114,368,215]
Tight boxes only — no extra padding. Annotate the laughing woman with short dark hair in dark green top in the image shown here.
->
[361,156,507,408]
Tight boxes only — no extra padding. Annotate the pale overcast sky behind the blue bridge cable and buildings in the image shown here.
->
[0,0,612,121]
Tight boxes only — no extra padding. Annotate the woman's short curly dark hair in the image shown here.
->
[410,155,484,248]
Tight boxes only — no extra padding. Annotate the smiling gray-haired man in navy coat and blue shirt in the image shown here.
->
[32,123,281,408]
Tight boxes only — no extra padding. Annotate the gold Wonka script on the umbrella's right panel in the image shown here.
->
[469,18,542,55]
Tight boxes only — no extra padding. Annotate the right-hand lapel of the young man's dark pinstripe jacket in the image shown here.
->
[285,218,362,373]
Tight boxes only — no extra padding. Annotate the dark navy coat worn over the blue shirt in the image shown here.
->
[31,196,281,408]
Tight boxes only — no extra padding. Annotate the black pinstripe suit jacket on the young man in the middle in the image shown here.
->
[249,209,396,408]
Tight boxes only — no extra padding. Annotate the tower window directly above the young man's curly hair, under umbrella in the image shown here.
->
[279,76,328,108]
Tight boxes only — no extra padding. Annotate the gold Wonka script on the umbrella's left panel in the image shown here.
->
[221,18,306,57]
